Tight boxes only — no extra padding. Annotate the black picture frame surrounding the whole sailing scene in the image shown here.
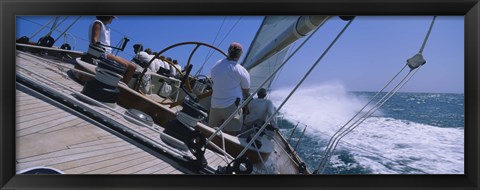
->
[0,0,480,189]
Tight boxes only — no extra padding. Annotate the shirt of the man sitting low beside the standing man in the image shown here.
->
[245,98,277,127]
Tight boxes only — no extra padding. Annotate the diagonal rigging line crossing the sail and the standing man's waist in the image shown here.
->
[207,15,328,147]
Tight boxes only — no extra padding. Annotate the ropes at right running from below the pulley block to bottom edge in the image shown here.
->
[317,69,418,172]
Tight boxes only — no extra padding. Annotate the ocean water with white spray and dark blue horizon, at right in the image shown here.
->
[269,85,465,174]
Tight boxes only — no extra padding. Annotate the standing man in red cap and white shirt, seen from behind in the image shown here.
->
[208,42,250,135]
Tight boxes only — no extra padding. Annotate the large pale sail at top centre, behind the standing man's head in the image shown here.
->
[242,16,329,91]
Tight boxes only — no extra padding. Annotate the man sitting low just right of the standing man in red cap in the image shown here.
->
[245,88,277,128]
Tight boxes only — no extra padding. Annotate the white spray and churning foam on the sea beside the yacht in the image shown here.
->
[270,83,464,174]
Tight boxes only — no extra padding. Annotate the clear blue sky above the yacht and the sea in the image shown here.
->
[16,16,464,93]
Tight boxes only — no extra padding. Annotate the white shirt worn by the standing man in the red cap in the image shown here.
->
[210,58,250,108]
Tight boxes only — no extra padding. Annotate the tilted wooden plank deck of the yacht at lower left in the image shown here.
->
[15,52,230,174]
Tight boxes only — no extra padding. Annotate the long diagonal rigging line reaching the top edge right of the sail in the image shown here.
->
[237,19,354,158]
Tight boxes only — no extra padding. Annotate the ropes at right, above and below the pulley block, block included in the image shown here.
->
[314,16,436,173]
